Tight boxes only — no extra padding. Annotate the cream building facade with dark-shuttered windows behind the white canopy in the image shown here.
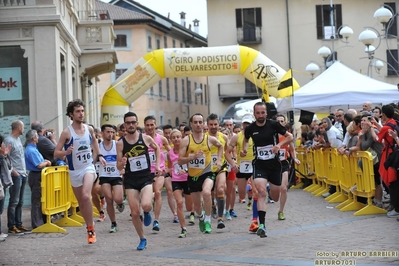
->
[207,0,399,117]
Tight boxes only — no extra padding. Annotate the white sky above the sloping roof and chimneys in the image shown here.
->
[102,0,208,37]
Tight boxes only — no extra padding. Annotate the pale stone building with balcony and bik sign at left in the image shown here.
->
[0,0,117,135]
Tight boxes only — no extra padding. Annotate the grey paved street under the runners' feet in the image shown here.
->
[0,190,399,266]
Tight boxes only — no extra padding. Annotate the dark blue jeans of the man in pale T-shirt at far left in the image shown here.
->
[7,175,28,229]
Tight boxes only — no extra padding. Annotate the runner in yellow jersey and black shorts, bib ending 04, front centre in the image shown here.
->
[178,113,223,234]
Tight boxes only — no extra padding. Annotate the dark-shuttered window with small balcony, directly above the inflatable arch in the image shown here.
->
[236,7,262,43]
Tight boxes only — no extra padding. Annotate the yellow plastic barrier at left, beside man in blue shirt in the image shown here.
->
[32,166,80,233]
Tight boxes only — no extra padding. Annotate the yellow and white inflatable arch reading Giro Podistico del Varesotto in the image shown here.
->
[101,45,294,124]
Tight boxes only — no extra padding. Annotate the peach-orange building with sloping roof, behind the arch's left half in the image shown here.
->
[97,1,209,126]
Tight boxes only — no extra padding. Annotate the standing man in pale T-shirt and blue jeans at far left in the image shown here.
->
[4,120,30,235]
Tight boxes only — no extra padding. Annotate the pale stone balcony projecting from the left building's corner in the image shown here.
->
[77,10,118,79]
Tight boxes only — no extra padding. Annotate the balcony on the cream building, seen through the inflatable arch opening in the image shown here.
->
[218,82,262,101]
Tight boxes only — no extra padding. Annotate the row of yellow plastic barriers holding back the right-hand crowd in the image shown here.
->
[296,148,387,216]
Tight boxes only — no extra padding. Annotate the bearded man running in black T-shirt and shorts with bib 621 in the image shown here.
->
[240,102,293,237]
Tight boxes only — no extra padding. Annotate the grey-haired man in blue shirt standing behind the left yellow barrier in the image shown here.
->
[25,129,51,229]
